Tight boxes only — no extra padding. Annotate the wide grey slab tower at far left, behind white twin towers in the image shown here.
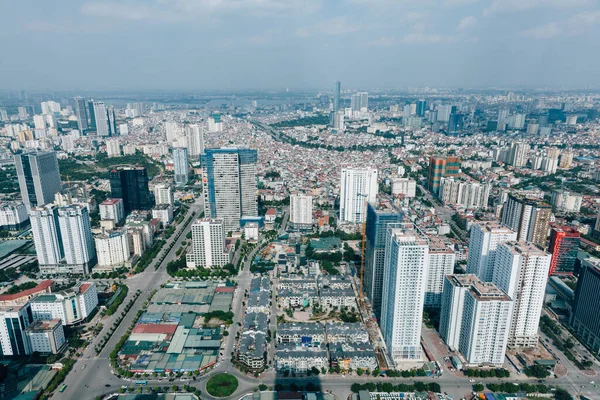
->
[15,151,62,210]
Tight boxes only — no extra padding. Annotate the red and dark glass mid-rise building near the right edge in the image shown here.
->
[548,226,581,275]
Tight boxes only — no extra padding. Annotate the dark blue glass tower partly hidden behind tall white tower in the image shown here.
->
[363,203,402,318]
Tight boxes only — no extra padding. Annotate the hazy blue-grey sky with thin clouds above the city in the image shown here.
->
[0,0,600,91]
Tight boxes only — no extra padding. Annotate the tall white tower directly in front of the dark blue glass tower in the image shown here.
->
[380,224,429,361]
